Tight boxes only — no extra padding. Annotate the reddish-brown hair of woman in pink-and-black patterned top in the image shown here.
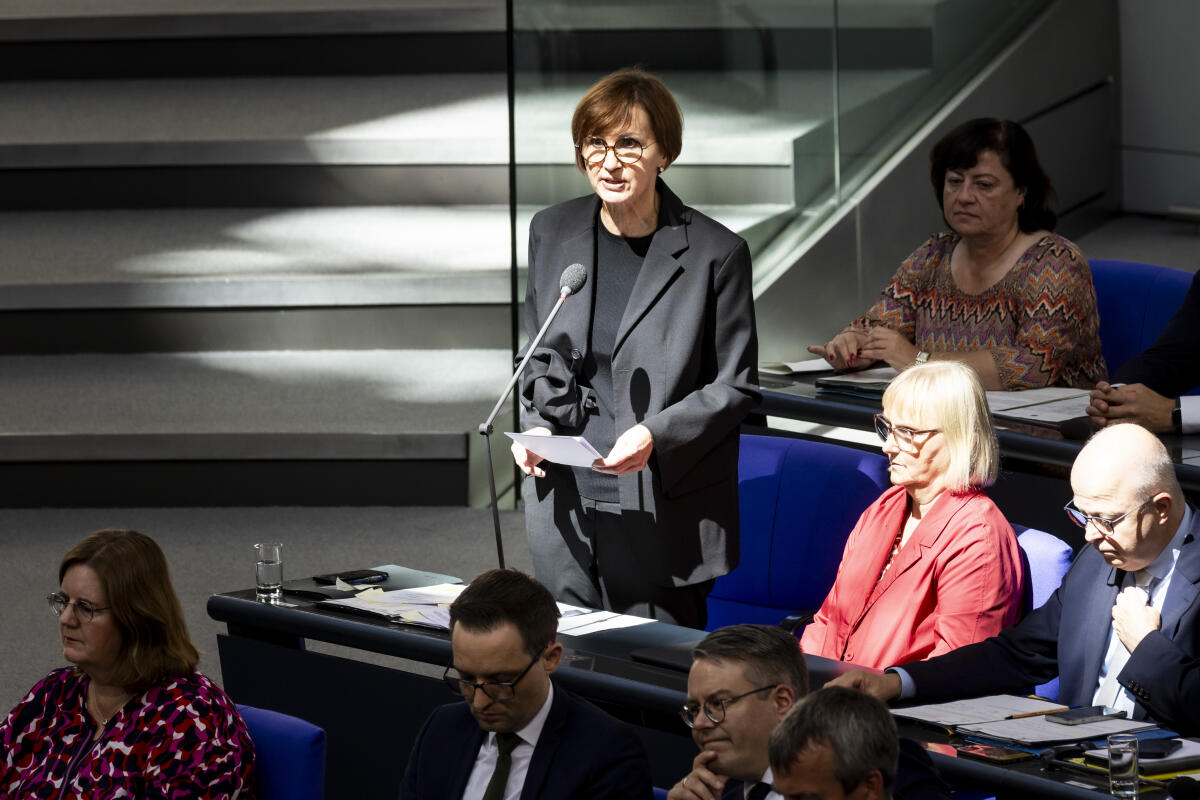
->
[59,530,200,691]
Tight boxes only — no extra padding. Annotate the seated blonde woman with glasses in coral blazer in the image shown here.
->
[800,361,1024,668]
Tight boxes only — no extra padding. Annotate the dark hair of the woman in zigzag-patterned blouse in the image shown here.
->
[929,118,1058,234]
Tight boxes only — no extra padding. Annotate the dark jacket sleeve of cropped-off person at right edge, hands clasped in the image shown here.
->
[1116,267,1200,397]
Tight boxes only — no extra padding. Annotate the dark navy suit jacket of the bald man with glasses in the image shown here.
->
[904,511,1200,735]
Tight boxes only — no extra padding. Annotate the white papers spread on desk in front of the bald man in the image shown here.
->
[892,694,1157,745]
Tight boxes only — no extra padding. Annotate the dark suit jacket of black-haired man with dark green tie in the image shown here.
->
[400,686,653,800]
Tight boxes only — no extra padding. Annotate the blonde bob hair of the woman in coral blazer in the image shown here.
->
[883,361,1000,493]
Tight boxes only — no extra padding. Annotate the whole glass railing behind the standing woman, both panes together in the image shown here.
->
[511,0,1050,323]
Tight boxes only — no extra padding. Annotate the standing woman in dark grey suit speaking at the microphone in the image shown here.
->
[512,70,758,627]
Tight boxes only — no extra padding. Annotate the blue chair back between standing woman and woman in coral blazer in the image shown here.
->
[708,434,889,631]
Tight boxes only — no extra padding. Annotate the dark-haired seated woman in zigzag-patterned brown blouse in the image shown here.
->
[809,119,1108,390]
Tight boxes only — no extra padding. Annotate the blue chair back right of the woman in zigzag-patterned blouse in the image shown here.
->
[1088,259,1192,375]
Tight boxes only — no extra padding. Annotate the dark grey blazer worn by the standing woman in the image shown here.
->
[521,179,760,587]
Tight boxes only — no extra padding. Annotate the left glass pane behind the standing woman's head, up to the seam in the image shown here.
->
[514,0,836,297]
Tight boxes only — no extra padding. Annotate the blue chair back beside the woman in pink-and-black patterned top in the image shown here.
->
[238,704,325,800]
